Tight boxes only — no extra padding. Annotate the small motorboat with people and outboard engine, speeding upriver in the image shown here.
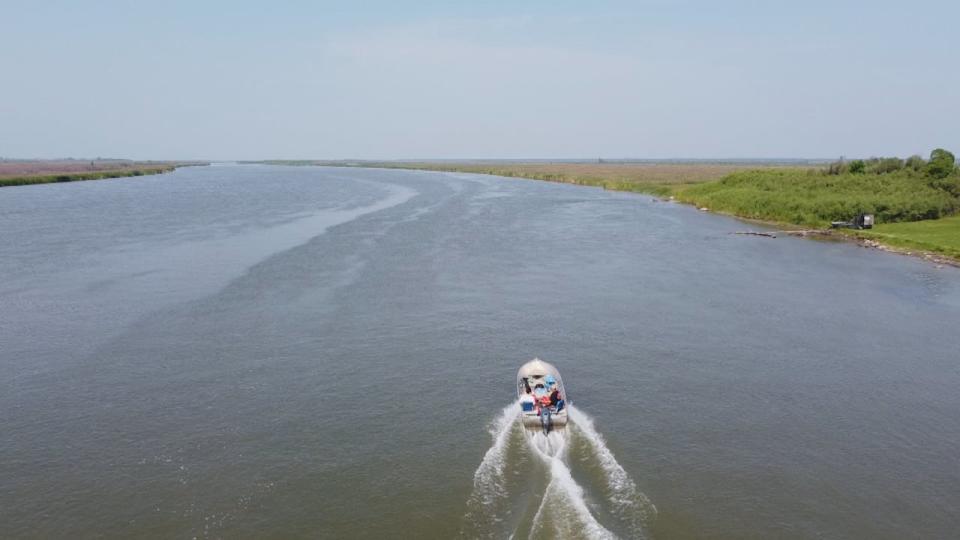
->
[517,358,569,433]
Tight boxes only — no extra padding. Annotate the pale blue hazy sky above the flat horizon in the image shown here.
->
[0,0,960,159]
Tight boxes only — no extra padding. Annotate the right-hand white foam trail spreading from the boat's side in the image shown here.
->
[568,406,657,537]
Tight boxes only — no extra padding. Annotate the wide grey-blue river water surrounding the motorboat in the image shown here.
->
[0,166,960,539]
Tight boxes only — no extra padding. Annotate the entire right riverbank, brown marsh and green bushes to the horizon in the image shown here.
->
[260,148,960,263]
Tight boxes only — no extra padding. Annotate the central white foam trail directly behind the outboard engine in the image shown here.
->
[526,431,616,538]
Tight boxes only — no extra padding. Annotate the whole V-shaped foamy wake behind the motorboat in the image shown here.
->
[460,403,656,538]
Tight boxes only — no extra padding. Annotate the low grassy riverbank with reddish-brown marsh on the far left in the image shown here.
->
[0,160,206,187]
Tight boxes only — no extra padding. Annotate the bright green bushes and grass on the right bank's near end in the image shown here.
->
[676,148,960,264]
